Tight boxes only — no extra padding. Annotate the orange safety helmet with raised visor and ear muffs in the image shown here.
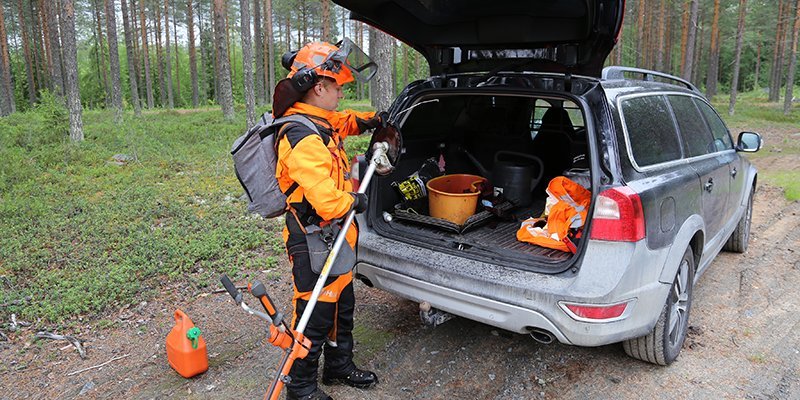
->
[281,38,378,92]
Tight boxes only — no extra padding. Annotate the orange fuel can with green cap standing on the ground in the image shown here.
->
[167,310,208,378]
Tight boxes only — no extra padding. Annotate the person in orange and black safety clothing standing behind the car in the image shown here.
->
[273,42,381,400]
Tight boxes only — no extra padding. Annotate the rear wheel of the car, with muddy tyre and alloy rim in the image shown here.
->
[622,247,695,365]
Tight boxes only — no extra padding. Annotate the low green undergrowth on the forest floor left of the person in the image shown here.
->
[0,99,376,323]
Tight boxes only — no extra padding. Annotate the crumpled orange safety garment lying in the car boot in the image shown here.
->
[517,176,592,253]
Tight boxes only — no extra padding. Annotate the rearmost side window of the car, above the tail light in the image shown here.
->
[621,96,682,167]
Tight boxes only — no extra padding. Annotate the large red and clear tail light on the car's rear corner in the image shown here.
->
[591,186,645,242]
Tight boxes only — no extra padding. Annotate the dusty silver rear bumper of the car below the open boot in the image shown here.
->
[356,231,670,346]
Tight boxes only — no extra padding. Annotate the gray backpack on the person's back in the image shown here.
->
[231,112,320,218]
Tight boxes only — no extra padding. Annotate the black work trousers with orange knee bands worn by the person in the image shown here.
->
[286,217,355,397]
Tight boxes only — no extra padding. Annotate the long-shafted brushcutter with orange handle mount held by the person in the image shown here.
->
[220,142,399,400]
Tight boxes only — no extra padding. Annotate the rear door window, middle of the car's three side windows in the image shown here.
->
[667,95,716,157]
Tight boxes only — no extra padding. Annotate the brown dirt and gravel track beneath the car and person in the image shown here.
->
[0,178,800,399]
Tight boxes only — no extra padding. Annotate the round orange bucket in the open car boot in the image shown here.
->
[426,174,486,225]
